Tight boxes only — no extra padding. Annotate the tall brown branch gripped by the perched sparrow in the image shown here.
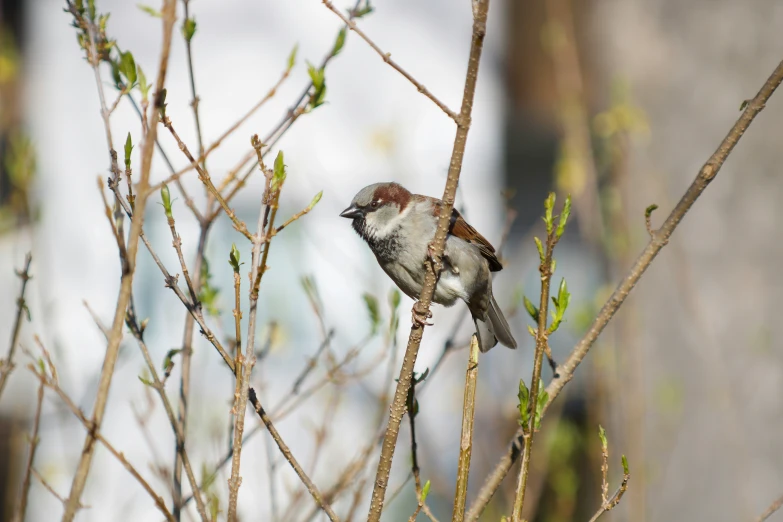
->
[368,0,489,522]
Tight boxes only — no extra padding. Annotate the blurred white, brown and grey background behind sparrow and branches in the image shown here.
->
[0,0,783,522]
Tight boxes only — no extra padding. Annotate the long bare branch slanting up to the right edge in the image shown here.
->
[468,55,783,521]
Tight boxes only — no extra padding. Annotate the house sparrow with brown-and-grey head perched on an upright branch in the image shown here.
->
[340,183,517,352]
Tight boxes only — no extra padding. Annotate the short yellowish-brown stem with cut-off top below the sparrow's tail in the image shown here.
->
[451,334,479,522]
